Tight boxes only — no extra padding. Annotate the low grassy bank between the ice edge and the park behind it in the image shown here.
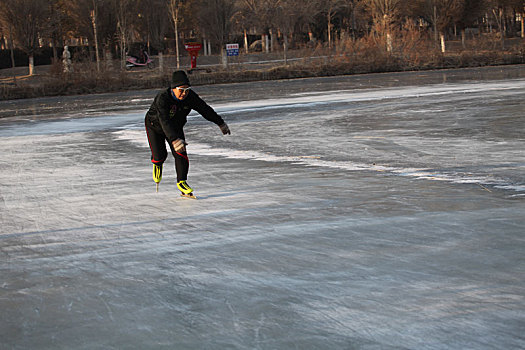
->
[0,40,525,100]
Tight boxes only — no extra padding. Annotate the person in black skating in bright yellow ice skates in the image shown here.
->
[145,70,230,198]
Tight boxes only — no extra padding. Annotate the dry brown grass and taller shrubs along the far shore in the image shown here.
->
[0,34,525,99]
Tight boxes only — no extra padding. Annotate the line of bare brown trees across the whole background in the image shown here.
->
[0,0,525,74]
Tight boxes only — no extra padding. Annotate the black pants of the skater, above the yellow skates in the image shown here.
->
[146,119,190,182]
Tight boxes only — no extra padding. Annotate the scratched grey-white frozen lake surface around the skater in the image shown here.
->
[0,66,525,349]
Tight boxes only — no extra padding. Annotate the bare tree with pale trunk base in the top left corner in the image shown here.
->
[0,0,49,75]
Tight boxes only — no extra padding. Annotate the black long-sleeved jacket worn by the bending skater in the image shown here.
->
[146,88,224,143]
